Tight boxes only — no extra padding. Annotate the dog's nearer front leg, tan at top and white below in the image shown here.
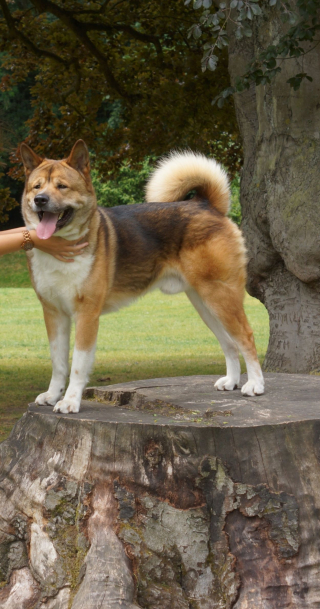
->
[54,313,99,413]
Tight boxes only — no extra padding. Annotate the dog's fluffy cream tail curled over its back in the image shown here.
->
[146,151,230,215]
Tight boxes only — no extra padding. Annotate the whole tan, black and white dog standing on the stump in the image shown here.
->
[21,140,264,413]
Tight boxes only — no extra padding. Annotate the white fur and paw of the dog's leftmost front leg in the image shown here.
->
[35,315,71,406]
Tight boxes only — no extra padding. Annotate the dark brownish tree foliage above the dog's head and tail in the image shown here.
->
[0,0,241,186]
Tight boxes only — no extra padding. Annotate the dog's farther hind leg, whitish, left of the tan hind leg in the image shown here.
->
[186,290,241,391]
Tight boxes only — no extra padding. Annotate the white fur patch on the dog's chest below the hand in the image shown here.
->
[31,250,93,315]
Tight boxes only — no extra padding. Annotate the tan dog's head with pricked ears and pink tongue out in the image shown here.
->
[20,140,96,239]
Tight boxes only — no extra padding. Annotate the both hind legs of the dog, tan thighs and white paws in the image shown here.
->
[187,282,264,396]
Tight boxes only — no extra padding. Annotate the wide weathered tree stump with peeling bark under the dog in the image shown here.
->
[0,374,320,609]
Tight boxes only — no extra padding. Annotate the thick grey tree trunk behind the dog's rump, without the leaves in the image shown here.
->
[229,6,320,372]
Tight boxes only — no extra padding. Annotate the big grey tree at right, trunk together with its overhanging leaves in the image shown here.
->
[191,0,320,372]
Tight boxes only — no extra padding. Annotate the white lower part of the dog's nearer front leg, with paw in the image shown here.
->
[53,345,96,414]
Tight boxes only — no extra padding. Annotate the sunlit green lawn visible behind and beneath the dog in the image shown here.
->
[0,253,269,440]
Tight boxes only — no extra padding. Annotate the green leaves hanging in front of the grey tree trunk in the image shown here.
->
[185,0,320,108]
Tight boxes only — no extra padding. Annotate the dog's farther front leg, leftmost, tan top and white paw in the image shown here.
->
[35,306,71,406]
